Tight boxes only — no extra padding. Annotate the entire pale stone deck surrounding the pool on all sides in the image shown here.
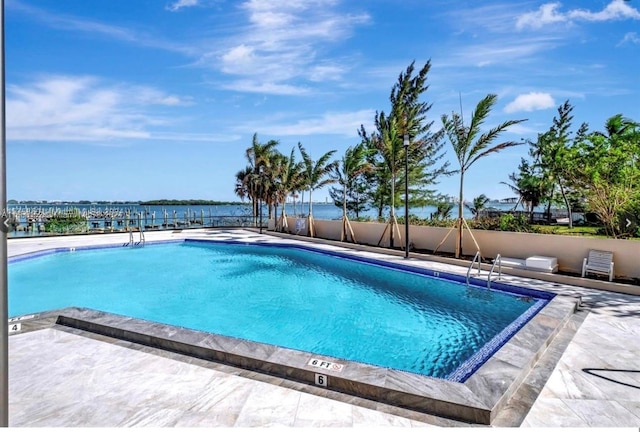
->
[9,230,640,427]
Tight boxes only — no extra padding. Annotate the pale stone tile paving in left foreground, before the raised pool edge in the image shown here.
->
[9,327,440,427]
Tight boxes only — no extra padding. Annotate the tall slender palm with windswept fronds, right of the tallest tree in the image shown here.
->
[442,94,525,258]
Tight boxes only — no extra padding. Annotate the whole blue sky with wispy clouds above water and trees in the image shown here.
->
[5,0,640,200]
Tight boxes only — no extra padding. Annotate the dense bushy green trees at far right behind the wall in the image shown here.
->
[506,101,640,237]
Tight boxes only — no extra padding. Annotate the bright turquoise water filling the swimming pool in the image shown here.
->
[9,242,544,378]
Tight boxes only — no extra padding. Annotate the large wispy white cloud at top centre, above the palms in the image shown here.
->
[208,0,370,94]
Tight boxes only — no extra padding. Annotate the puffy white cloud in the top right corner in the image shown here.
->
[516,0,640,29]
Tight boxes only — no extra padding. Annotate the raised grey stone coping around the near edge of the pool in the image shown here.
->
[12,238,577,425]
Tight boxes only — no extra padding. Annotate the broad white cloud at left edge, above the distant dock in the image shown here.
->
[7,76,189,142]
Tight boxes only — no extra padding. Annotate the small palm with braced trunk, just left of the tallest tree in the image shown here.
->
[331,143,373,243]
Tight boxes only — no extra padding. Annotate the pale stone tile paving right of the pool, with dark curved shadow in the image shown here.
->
[522,308,640,427]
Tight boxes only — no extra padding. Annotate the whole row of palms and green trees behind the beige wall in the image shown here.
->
[235,61,640,250]
